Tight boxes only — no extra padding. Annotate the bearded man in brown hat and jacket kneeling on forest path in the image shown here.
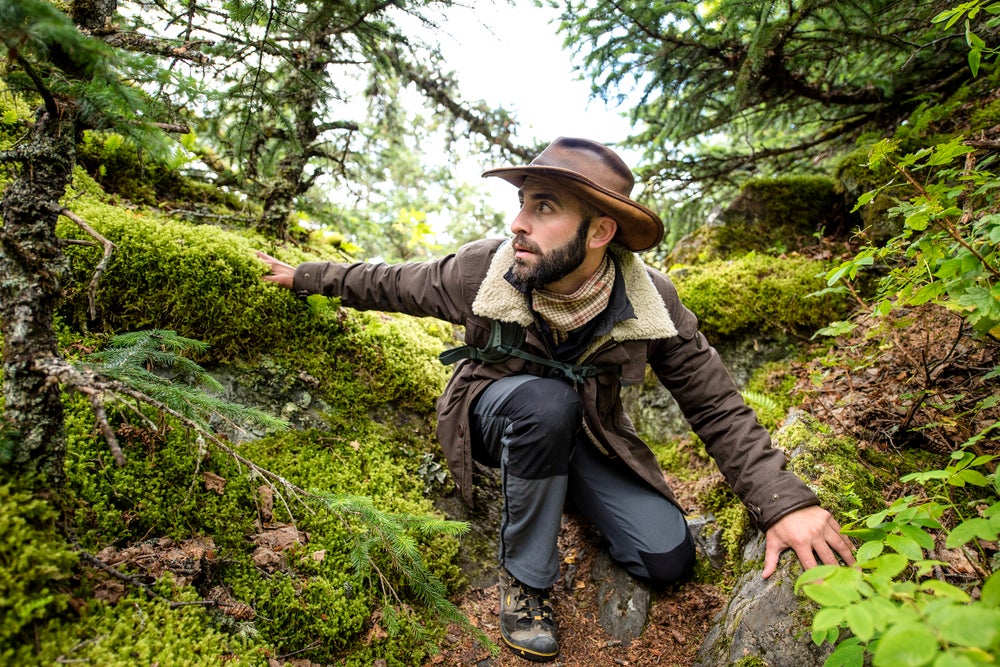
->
[258,137,854,661]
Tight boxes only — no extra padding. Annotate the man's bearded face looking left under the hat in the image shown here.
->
[510,178,590,289]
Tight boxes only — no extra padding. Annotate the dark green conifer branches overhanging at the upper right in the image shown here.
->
[556,0,1000,228]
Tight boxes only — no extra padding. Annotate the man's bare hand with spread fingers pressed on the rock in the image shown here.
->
[761,505,854,579]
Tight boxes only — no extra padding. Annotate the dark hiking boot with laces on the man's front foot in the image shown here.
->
[500,568,559,662]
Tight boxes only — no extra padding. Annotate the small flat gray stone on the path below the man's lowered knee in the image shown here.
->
[591,549,651,644]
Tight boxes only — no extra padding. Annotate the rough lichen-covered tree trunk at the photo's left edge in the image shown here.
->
[0,106,76,486]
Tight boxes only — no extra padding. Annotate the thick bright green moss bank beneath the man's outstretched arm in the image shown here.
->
[54,190,448,412]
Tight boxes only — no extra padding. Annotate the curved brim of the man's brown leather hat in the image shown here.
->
[483,165,663,252]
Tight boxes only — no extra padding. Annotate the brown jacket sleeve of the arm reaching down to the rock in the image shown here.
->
[649,274,819,530]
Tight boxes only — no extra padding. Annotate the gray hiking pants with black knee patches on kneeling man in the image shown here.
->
[471,375,694,588]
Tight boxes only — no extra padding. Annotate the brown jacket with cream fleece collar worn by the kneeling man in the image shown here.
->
[294,240,818,530]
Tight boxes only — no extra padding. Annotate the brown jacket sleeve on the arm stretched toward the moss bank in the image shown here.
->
[292,241,498,324]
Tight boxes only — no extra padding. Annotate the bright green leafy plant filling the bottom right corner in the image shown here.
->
[795,434,1000,667]
